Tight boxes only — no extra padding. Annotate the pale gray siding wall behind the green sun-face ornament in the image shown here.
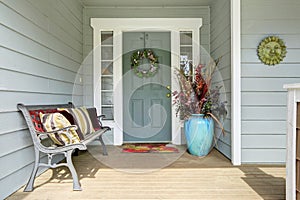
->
[241,0,300,163]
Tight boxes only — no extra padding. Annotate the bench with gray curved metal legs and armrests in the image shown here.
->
[17,103,110,192]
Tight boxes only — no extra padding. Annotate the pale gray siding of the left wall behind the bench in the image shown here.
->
[0,0,83,199]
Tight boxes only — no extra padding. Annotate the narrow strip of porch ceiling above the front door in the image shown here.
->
[81,0,212,7]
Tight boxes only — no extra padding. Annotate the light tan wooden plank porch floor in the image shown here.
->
[8,147,285,200]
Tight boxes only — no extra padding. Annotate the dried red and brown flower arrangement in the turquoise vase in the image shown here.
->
[173,59,227,131]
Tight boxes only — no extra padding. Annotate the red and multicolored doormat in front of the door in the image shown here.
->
[122,144,179,153]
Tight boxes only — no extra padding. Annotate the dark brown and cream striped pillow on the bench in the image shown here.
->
[57,107,95,135]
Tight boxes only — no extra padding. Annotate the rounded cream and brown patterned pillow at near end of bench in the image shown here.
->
[40,113,80,145]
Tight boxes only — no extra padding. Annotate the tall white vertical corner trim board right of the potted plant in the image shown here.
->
[231,0,242,165]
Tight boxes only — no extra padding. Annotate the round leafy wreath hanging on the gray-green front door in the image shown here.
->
[131,49,159,78]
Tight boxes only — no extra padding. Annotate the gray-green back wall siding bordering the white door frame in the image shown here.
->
[83,6,210,144]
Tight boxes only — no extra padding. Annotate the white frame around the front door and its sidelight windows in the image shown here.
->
[91,18,202,145]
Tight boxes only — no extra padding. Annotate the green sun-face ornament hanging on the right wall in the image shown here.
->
[257,36,287,65]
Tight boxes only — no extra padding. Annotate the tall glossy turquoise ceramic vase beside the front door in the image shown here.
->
[184,114,214,156]
